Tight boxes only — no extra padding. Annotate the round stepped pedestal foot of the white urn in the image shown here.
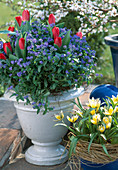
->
[25,141,68,165]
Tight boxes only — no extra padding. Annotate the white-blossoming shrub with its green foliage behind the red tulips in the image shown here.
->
[0,0,118,57]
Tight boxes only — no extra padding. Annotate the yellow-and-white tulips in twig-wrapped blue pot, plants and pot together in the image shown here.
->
[57,95,118,170]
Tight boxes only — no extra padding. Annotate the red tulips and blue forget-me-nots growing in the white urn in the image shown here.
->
[0,10,95,114]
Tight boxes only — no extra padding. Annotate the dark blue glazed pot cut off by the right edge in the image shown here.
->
[104,34,118,87]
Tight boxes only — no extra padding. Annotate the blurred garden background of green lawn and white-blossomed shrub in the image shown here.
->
[0,0,118,96]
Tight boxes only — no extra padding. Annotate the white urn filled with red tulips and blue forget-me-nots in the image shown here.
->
[0,10,95,165]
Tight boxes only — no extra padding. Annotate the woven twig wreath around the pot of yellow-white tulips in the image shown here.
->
[70,140,118,164]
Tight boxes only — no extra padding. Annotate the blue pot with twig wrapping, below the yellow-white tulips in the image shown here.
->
[73,140,118,170]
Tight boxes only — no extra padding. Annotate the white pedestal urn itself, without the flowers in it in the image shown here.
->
[4,87,84,165]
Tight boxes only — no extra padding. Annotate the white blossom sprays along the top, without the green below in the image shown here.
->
[18,0,118,34]
